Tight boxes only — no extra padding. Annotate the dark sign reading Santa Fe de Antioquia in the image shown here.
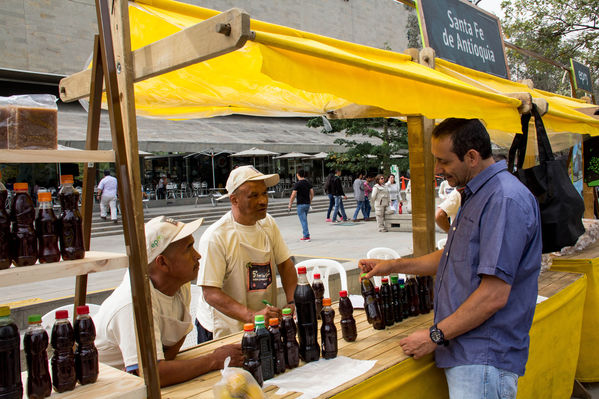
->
[418,0,509,79]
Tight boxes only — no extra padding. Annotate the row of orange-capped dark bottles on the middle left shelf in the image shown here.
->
[0,175,85,269]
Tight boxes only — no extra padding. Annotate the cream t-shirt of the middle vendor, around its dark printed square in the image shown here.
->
[196,211,291,338]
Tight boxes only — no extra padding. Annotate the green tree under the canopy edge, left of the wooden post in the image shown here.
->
[307,118,409,174]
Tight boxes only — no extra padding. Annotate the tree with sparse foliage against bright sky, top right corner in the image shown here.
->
[501,0,599,96]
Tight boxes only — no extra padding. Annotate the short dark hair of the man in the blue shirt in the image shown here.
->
[433,118,493,161]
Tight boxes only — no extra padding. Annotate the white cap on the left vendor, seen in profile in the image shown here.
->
[145,216,204,263]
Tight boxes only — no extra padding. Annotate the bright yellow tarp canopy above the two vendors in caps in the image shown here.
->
[129,0,520,132]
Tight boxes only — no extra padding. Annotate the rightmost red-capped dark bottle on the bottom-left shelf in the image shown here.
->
[75,305,98,385]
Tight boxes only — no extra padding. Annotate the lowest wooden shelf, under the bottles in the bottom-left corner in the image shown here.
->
[21,363,146,399]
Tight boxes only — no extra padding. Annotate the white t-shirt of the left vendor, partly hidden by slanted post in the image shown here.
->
[94,271,193,370]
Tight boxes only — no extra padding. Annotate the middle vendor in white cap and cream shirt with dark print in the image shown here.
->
[196,166,297,342]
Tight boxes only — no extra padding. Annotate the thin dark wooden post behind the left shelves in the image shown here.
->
[73,35,104,318]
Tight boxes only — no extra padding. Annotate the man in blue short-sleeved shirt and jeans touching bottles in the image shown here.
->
[359,118,542,399]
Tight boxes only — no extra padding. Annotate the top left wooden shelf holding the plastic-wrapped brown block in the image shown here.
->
[0,150,114,163]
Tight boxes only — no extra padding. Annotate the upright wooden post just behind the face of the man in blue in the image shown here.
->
[406,48,435,256]
